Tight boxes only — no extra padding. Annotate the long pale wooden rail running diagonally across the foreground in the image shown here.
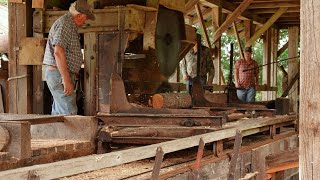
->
[0,116,296,179]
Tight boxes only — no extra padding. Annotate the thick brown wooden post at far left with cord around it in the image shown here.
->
[8,1,32,114]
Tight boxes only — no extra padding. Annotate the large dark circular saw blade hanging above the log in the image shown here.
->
[155,6,185,77]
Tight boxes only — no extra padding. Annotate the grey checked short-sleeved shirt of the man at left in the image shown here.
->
[43,13,83,74]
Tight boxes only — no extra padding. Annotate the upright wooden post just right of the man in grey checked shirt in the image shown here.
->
[84,33,97,116]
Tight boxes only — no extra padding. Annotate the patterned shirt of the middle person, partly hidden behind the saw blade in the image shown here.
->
[180,46,214,80]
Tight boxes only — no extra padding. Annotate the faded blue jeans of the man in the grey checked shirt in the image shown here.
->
[45,66,78,115]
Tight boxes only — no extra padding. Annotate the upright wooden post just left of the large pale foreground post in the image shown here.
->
[288,27,300,112]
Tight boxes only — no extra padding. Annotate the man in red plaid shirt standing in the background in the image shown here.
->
[234,47,259,102]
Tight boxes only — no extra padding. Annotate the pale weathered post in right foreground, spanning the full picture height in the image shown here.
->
[300,0,320,179]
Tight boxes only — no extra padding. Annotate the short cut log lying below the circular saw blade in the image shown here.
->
[152,93,191,109]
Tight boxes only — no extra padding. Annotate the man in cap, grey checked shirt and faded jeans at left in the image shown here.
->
[43,0,95,115]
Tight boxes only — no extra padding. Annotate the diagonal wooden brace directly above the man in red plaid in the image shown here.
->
[246,8,288,47]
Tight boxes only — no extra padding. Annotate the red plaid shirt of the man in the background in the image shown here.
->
[235,59,259,89]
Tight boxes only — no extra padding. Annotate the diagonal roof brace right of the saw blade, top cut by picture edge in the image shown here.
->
[213,0,253,43]
